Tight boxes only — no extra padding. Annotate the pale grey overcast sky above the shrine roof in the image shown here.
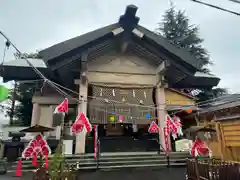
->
[0,0,240,122]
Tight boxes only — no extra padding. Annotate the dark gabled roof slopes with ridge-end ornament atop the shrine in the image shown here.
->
[39,5,202,70]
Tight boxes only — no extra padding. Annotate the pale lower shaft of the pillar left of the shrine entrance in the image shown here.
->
[75,81,88,154]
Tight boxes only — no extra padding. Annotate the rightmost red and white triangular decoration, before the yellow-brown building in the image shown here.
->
[191,137,212,158]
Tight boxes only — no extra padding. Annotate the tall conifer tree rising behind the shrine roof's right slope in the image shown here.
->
[156,4,228,101]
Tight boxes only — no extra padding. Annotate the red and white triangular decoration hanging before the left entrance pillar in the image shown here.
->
[71,112,92,133]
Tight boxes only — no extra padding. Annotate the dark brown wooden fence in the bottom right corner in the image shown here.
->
[186,159,240,180]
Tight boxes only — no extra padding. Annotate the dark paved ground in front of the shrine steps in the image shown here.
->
[0,168,185,180]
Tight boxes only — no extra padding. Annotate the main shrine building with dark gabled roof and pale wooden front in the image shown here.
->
[2,5,220,153]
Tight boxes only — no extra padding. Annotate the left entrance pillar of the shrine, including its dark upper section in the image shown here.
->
[75,55,88,154]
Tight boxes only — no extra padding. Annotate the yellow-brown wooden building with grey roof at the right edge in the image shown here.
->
[196,94,240,161]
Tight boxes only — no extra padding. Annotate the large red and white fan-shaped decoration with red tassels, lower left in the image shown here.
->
[16,134,51,177]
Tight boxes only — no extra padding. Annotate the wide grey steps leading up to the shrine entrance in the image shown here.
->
[8,152,190,173]
